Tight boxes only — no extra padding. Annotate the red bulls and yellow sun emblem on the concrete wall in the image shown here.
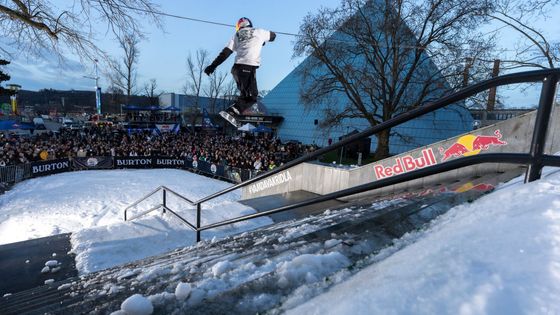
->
[439,130,507,162]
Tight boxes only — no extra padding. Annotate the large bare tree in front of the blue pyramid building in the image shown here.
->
[295,0,492,159]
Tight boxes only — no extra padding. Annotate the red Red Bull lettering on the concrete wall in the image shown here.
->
[373,148,437,179]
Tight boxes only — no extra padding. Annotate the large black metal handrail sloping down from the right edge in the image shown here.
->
[127,69,560,242]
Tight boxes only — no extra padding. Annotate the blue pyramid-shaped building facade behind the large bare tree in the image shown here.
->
[263,1,473,154]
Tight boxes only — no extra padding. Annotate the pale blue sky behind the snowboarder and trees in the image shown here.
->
[1,0,560,107]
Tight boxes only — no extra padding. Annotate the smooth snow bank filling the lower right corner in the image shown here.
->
[288,171,560,314]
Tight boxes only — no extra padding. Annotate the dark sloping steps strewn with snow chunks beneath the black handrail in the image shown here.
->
[0,179,498,314]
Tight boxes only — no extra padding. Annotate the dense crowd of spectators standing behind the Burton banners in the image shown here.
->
[0,126,315,170]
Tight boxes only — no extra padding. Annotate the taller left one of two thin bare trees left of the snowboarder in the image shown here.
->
[183,49,208,132]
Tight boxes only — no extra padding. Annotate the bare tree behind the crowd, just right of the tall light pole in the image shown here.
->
[110,34,140,103]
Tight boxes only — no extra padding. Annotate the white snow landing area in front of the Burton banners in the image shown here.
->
[0,169,272,273]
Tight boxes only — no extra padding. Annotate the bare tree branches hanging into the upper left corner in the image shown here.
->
[0,0,161,60]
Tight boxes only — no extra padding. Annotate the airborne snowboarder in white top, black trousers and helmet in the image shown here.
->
[204,17,276,115]
